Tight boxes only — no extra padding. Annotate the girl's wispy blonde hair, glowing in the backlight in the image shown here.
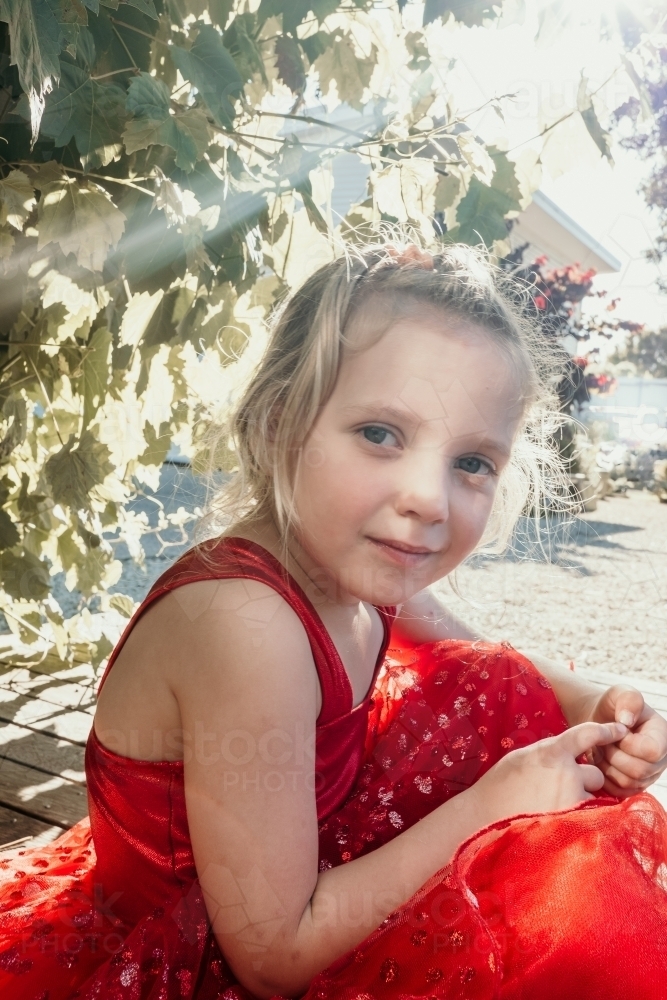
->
[200,241,563,552]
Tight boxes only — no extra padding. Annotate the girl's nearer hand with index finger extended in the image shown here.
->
[467,722,628,824]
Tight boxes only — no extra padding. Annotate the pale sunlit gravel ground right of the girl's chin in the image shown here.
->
[443,491,667,681]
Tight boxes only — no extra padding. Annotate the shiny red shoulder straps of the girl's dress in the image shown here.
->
[98,537,396,727]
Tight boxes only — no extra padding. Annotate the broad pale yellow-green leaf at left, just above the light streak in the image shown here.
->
[37,179,125,271]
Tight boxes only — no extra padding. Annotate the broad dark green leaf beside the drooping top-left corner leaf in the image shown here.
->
[41,63,127,170]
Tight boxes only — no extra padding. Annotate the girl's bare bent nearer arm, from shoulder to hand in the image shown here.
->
[168,580,620,998]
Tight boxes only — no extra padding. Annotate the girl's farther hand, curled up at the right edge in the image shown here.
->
[589,684,667,798]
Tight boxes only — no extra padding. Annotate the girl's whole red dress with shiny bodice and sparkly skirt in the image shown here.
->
[0,539,667,1000]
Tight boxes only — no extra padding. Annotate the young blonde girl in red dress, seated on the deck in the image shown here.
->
[0,245,667,1000]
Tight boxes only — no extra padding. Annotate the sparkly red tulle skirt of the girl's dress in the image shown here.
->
[0,642,667,1000]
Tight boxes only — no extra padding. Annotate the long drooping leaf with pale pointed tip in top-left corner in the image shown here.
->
[0,0,64,142]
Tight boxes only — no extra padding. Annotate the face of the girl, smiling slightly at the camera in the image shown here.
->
[295,316,522,605]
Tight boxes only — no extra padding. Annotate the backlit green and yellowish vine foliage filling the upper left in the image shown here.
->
[0,0,548,662]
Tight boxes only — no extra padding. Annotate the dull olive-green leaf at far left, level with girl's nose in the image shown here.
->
[44,431,112,510]
